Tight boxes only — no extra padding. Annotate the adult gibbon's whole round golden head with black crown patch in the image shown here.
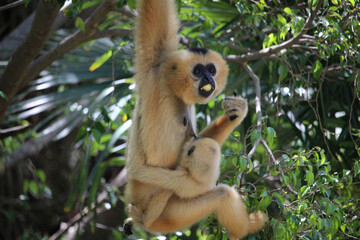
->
[161,48,229,105]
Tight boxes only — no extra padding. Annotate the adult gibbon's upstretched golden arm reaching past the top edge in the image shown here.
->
[135,0,179,73]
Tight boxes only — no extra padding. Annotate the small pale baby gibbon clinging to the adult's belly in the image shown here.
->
[127,138,221,229]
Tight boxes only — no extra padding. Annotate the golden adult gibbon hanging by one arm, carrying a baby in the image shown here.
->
[125,0,267,239]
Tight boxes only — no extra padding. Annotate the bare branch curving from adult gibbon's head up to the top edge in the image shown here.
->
[225,0,323,63]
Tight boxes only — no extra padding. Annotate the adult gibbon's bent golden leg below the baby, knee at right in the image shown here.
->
[150,184,264,239]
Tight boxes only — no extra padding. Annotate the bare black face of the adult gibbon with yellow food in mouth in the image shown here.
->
[192,63,216,98]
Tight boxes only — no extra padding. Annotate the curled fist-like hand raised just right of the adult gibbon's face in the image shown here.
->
[222,96,248,121]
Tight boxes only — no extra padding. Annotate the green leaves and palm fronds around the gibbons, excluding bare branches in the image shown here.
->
[0,0,360,239]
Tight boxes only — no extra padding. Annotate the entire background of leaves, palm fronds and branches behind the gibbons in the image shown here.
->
[0,0,360,240]
